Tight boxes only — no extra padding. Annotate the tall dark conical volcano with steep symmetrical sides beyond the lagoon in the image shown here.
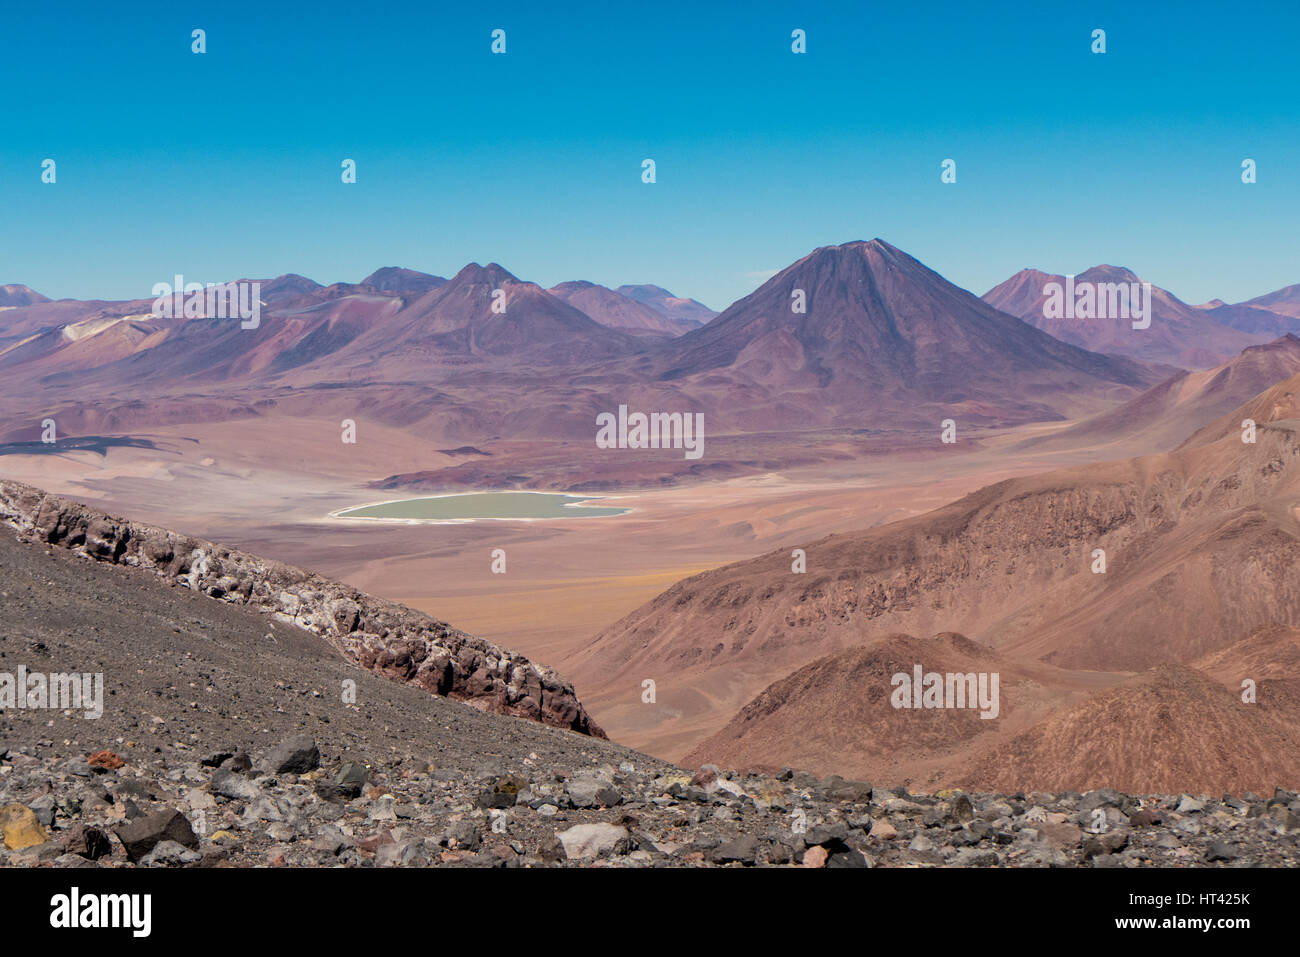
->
[657,239,1154,428]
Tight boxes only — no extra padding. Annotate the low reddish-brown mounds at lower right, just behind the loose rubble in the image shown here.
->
[685,625,1300,793]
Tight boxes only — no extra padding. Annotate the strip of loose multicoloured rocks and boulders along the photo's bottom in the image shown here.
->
[10,737,1300,867]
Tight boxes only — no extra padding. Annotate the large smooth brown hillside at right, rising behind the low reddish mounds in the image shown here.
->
[575,377,1300,754]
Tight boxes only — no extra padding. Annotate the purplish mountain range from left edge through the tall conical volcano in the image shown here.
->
[0,239,1268,441]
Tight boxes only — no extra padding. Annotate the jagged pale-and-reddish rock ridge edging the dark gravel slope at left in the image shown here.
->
[0,480,605,737]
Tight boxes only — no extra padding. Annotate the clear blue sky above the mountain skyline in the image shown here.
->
[0,0,1300,308]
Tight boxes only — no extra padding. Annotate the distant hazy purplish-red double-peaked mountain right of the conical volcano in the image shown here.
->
[983,265,1275,369]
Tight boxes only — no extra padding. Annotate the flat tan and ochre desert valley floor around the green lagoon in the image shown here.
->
[0,420,1118,761]
